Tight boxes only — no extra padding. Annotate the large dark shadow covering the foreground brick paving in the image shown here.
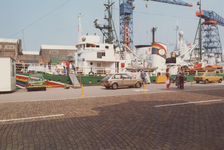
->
[0,94,224,150]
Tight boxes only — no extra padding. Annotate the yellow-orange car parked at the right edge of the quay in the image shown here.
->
[194,72,223,83]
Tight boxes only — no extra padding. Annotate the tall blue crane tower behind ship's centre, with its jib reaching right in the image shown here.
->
[119,0,193,48]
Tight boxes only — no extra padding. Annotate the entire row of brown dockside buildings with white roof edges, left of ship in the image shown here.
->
[0,38,77,64]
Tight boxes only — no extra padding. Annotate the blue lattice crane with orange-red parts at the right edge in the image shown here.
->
[196,10,224,56]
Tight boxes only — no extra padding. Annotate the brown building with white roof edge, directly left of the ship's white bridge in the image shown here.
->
[40,45,77,64]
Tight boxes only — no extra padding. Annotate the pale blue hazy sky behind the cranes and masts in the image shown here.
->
[0,0,224,51]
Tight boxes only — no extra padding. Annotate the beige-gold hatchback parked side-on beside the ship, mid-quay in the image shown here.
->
[101,73,143,89]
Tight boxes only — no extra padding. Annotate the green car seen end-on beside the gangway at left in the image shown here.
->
[26,74,46,92]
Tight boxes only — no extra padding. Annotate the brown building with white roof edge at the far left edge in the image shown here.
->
[0,38,22,62]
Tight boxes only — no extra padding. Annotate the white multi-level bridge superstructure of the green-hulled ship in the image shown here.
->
[75,35,121,75]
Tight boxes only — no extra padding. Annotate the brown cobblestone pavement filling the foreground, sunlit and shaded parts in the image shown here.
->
[0,89,224,150]
